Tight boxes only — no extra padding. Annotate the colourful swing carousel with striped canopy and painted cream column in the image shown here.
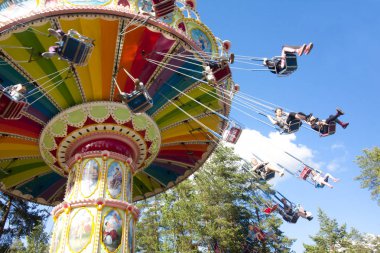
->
[0,0,241,252]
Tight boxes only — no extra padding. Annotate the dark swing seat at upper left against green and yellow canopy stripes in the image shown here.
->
[58,34,94,66]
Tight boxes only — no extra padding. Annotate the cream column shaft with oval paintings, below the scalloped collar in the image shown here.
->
[50,149,139,253]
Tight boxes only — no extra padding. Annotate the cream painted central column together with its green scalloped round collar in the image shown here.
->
[40,101,161,253]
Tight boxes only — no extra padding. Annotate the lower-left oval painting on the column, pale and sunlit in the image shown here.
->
[69,209,92,252]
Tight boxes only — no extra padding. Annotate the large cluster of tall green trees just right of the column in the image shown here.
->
[136,147,292,253]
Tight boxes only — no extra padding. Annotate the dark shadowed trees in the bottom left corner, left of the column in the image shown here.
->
[0,193,49,252]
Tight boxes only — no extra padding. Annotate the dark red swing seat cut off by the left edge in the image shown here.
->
[0,85,29,120]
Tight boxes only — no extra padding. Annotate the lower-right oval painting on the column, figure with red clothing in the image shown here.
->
[102,210,123,252]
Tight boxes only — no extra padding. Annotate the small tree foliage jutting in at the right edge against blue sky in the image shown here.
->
[355,147,380,205]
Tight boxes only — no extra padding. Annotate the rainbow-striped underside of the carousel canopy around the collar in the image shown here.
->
[0,10,229,205]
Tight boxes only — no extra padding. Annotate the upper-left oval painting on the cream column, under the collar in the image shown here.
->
[81,160,99,196]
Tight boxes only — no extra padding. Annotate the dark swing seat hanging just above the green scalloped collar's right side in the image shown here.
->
[124,89,153,113]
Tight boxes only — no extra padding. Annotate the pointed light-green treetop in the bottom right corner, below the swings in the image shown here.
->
[304,209,380,253]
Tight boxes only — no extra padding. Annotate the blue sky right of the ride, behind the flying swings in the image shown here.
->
[197,0,380,252]
